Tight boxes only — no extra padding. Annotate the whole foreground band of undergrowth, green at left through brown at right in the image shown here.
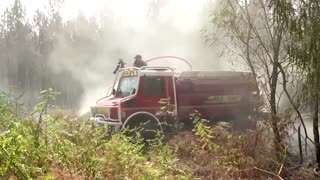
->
[0,90,292,179]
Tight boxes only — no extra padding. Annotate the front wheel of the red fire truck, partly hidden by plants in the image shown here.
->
[124,113,162,140]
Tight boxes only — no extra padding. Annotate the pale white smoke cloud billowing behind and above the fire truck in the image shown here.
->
[50,0,235,114]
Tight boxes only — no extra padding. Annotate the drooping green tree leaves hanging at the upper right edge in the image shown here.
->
[288,0,320,94]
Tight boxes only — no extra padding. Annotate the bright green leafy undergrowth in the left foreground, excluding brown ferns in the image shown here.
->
[0,89,188,179]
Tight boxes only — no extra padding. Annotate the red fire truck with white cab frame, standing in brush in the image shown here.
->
[91,66,257,134]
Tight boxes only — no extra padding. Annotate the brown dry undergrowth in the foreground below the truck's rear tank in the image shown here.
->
[168,126,281,179]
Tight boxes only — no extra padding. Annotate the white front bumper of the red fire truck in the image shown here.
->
[90,117,122,132]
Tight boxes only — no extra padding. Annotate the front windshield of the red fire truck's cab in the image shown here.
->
[116,76,138,97]
